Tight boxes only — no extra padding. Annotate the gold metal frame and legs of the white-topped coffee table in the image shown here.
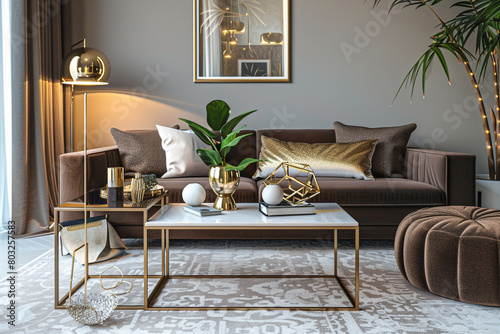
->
[144,206,359,311]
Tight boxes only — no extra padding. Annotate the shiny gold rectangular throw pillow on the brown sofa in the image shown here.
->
[253,136,377,180]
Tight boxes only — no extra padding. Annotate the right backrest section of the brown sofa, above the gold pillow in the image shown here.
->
[256,129,335,157]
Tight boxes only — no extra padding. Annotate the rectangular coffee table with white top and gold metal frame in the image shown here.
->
[143,203,359,311]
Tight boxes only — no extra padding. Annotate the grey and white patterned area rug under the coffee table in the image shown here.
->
[0,240,500,334]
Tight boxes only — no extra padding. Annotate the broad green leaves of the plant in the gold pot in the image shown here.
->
[179,100,261,171]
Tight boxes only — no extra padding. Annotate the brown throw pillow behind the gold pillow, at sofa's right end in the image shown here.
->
[333,122,417,177]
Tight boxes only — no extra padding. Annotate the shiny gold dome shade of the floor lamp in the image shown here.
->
[62,47,111,86]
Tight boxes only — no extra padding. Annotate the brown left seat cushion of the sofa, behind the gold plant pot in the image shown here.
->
[158,176,257,204]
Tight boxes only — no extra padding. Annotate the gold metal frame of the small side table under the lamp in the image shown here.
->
[54,191,168,310]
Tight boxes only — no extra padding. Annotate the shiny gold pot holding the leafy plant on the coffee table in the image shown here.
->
[208,166,240,211]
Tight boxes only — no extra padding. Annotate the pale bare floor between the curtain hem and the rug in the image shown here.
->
[0,231,54,278]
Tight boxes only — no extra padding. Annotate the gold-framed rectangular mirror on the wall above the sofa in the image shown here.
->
[194,0,290,82]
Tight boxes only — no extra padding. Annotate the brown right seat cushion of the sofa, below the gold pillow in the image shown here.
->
[258,177,446,206]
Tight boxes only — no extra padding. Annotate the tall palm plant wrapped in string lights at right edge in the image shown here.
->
[374,0,500,180]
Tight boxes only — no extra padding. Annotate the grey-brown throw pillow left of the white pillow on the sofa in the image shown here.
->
[109,125,179,177]
